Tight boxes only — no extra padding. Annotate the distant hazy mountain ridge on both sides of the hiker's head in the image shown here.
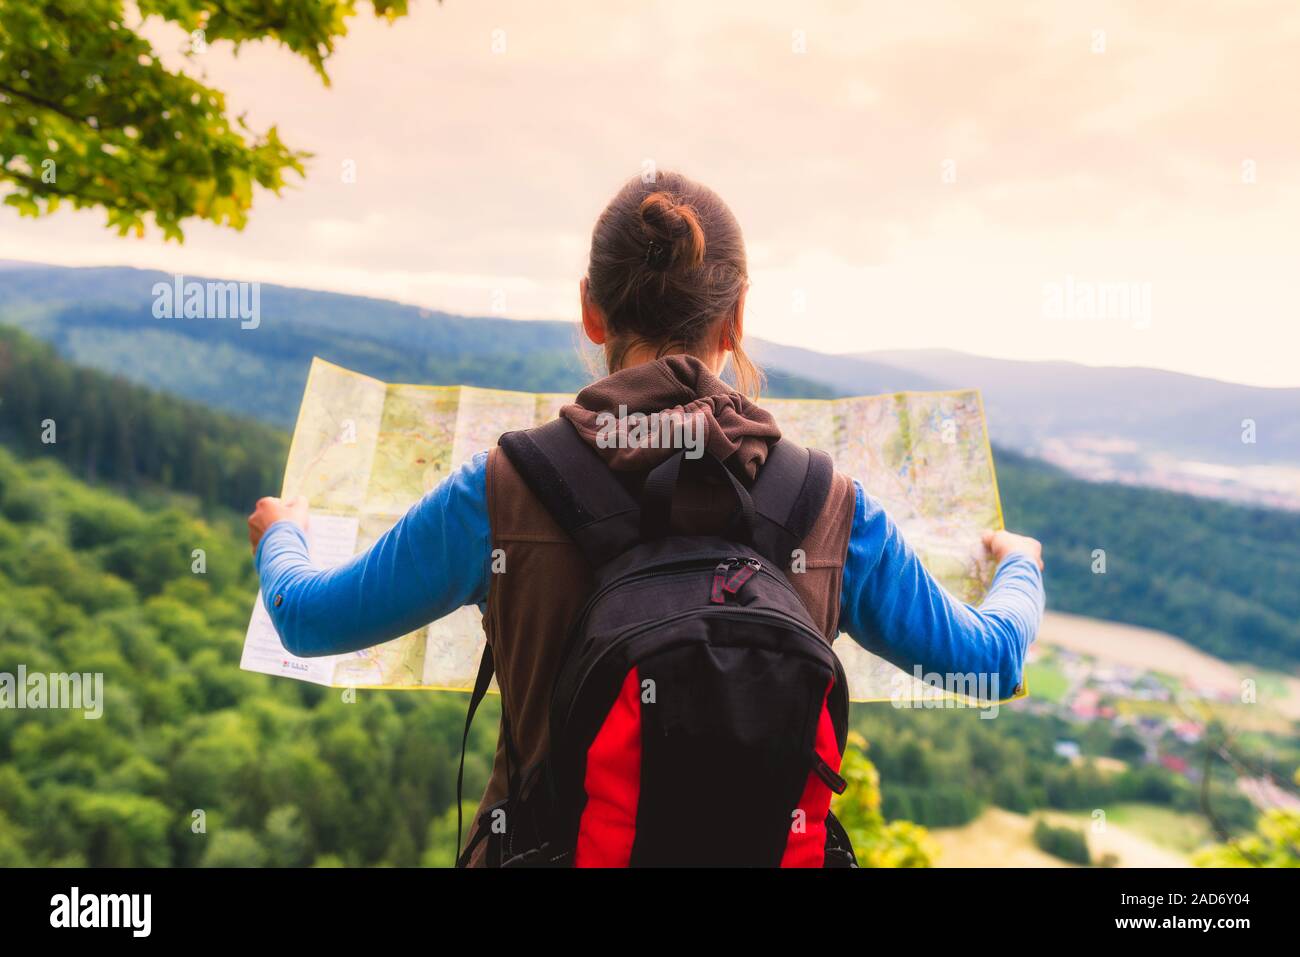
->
[0,261,1300,508]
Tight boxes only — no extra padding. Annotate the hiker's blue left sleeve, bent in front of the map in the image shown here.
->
[254,452,491,658]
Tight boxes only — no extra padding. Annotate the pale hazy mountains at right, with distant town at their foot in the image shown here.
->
[863,350,1300,508]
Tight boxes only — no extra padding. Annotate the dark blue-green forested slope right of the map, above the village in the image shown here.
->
[997,451,1300,670]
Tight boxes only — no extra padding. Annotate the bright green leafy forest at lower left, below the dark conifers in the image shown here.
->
[0,450,497,866]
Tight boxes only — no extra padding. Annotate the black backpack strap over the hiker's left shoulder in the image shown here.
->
[498,419,641,566]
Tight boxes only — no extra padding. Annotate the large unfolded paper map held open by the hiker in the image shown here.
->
[241,359,1002,701]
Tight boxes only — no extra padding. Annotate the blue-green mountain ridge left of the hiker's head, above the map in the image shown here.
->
[0,263,833,426]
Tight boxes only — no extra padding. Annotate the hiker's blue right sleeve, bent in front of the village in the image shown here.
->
[840,482,1044,697]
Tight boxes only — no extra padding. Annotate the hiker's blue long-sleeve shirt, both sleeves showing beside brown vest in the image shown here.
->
[255,452,1044,693]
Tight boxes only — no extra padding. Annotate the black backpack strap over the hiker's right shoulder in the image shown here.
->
[750,439,835,568]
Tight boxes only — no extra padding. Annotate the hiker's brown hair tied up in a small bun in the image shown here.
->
[586,172,762,395]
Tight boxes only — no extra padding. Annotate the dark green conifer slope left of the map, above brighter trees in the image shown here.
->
[0,325,287,510]
